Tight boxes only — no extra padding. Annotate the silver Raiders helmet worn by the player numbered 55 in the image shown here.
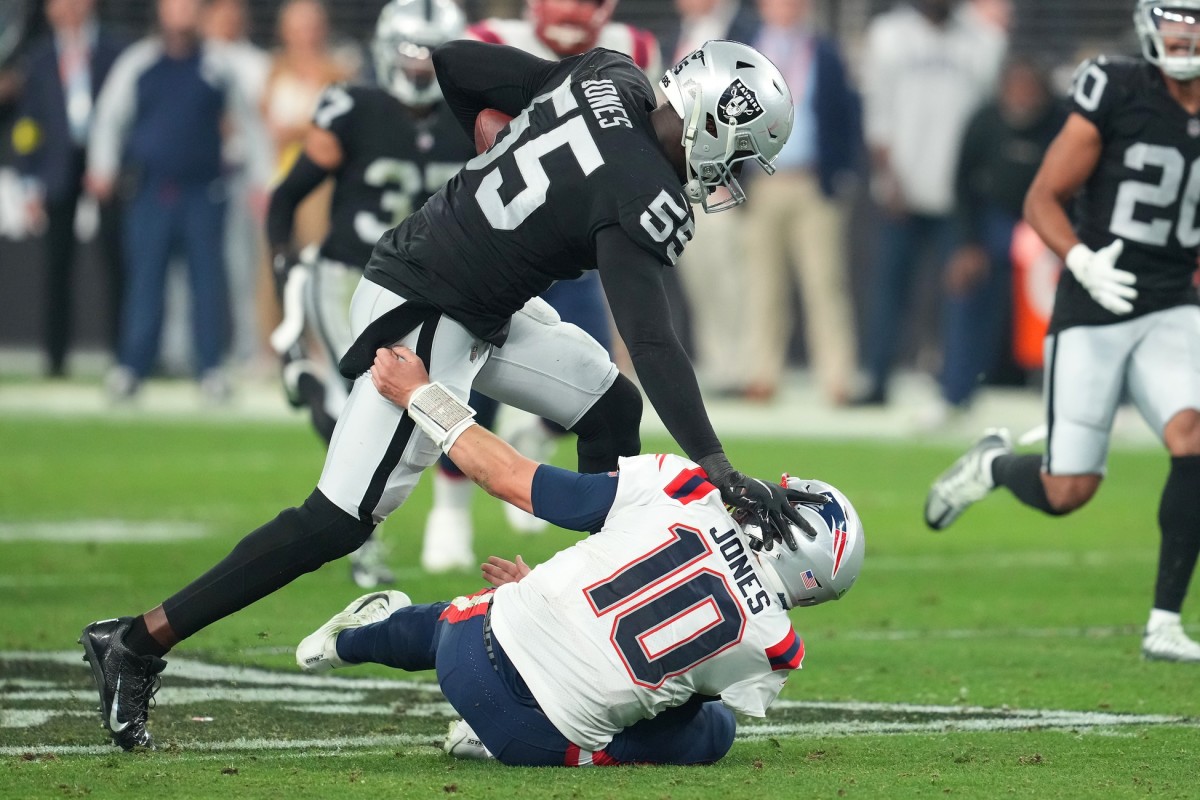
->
[659,40,794,213]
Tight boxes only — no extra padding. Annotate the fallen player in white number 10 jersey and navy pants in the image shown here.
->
[296,347,865,766]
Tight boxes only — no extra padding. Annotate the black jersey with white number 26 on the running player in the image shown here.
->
[1050,56,1200,332]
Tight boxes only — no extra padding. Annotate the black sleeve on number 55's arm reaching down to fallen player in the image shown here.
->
[596,225,721,461]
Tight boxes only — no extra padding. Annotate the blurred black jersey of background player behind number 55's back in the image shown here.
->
[313,85,475,267]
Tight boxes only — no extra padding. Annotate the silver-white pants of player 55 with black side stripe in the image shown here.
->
[317,279,617,523]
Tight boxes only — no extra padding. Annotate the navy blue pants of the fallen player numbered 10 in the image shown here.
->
[337,602,736,766]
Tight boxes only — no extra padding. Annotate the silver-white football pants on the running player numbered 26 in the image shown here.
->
[1043,306,1200,475]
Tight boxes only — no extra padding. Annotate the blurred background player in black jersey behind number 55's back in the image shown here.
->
[266,0,475,589]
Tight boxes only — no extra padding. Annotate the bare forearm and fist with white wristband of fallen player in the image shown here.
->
[371,345,539,513]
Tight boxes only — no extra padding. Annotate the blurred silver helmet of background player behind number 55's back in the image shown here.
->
[371,0,467,108]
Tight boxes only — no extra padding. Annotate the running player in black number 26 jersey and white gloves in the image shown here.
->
[925,0,1200,662]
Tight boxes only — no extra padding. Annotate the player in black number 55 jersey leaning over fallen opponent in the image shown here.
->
[80,41,816,748]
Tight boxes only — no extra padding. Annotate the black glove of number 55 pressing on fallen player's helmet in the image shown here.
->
[700,453,827,551]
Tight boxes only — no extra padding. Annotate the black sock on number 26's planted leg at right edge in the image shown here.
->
[1154,456,1200,612]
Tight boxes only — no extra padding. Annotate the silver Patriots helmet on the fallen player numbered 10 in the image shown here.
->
[751,475,866,608]
